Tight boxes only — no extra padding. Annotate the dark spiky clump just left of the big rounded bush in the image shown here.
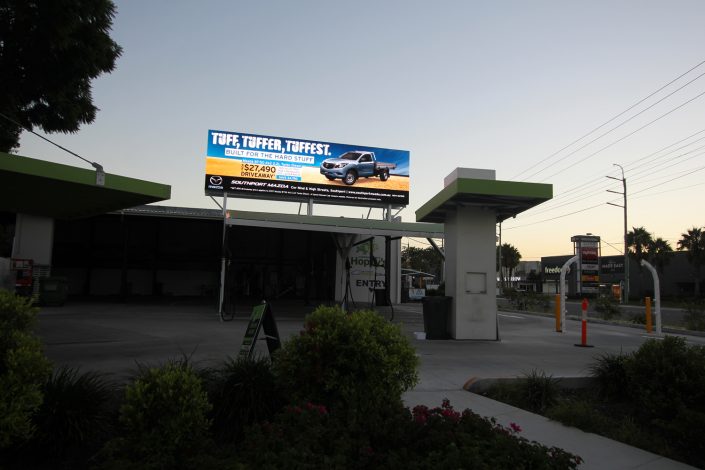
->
[204,358,286,442]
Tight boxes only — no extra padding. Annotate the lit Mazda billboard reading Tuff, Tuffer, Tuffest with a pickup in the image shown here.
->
[205,130,409,206]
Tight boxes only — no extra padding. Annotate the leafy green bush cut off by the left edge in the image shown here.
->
[0,291,51,449]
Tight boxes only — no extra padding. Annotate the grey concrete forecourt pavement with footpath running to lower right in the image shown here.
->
[37,303,705,469]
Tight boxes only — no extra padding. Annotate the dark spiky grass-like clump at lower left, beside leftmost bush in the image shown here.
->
[29,368,117,468]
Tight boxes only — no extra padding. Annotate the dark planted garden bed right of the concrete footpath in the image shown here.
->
[474,337,705,468]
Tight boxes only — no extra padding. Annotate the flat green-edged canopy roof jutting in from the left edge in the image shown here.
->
[0,152,171,219]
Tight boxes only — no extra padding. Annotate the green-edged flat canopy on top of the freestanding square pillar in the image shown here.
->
[416,178,553,223]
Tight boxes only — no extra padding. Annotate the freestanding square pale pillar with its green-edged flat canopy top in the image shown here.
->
[416,168,553,340]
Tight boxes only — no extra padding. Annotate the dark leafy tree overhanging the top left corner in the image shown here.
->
[0,0,122,152]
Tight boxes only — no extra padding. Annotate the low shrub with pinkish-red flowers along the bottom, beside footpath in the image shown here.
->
[242,400,581,470]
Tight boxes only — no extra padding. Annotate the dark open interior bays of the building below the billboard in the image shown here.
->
[52,213,336,302]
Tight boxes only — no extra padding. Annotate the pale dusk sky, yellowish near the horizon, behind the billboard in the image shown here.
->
[13,0,705,259]
